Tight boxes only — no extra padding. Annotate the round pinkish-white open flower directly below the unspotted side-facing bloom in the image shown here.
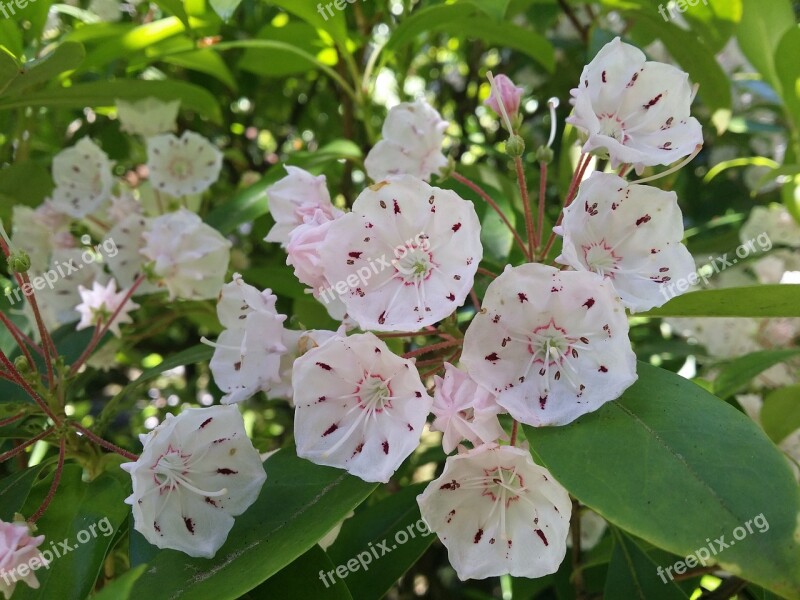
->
[320,176,483,331]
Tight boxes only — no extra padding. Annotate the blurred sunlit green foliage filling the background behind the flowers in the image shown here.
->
[0,0,800,599]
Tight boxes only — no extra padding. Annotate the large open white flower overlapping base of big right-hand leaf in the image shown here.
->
[461,263,636,426]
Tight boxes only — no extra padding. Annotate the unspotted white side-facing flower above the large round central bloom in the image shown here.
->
[364,100,449,181]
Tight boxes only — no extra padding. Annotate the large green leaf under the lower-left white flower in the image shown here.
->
[134,448,376,600]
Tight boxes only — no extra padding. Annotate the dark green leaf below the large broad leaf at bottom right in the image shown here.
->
[604,528,688,600]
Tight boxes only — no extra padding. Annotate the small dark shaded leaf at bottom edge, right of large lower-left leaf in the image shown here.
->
[252,545,352,600]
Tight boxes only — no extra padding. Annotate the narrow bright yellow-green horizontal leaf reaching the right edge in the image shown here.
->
[641,286,800,317]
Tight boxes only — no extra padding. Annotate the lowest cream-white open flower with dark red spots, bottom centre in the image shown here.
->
[417,444,572,581]
